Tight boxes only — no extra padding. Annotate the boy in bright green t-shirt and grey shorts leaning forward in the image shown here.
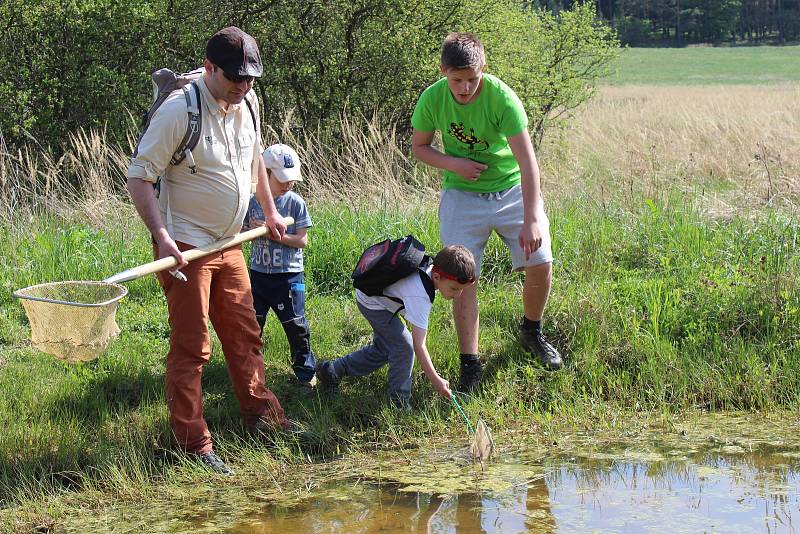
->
[411,33,561,391]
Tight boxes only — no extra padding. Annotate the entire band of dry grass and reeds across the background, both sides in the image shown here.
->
[0,85,800,224]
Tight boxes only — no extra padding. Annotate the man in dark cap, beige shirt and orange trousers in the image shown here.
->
[127,26,292,475]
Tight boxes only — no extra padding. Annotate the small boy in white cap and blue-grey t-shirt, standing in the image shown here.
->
[244,144,316,388]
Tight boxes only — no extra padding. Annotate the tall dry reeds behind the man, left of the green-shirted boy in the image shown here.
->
[0,113,438,225]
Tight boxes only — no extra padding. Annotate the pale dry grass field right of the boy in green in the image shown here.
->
[540,85,800,215]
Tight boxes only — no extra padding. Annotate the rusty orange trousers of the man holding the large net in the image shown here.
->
[153,242,288,454]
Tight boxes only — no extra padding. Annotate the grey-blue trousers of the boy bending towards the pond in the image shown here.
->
[333,303,414,401]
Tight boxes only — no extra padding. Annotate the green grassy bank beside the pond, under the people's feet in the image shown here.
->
[0,200,800,523]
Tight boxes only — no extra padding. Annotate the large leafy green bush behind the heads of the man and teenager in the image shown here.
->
[0,0,617,153]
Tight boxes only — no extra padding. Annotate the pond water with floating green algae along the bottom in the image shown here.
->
[68,416,800,534]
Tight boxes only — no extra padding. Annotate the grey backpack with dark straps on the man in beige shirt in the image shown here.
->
[133,67,260,179]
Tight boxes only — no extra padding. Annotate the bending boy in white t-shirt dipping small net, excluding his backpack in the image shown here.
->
[317,246,475,410]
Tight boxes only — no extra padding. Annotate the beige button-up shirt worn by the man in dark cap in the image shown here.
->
[128,79,261,247]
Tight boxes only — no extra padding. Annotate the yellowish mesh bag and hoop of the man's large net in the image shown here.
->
[14,282,128,363]
